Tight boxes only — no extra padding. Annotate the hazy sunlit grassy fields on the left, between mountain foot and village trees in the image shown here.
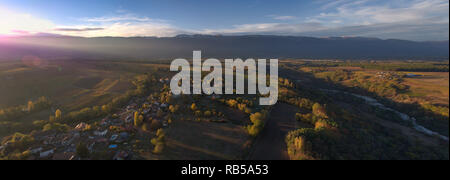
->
[0,60,166,138]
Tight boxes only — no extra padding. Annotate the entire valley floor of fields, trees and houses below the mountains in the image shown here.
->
[0,60,449,160]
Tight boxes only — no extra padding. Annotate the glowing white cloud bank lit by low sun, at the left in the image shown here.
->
[0,7,183,37]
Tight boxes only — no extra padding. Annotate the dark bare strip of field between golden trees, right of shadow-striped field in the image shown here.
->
[249,103,297,160]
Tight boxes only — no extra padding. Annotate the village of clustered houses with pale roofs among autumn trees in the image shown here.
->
[0,78,174,160]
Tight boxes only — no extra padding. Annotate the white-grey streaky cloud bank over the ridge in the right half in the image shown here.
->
[202,0,449,41]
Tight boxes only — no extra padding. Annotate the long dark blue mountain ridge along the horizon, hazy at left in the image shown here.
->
[0,35,449,60]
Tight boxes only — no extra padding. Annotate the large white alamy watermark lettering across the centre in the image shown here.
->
[170,51,278,105]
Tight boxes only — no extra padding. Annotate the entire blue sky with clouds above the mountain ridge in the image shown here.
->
[0,0,449,41]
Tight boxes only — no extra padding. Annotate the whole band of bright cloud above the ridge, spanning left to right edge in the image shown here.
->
[0,0,449,41]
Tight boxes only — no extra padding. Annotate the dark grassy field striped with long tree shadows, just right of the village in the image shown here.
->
[162,121,248,160]
